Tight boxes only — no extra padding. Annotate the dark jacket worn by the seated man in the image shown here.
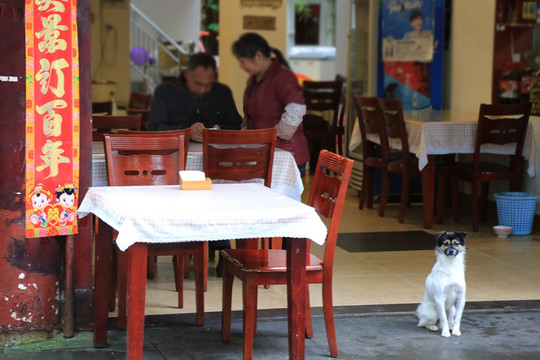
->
[147,76,242,131]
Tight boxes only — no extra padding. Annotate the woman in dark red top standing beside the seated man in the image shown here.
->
[232,33,309,175]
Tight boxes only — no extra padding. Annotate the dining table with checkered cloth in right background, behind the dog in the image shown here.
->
[349,109,536,229]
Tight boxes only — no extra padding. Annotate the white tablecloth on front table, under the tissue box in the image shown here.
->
[78,183,327,250]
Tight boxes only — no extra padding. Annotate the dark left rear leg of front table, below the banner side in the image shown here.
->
[94,218,116,347]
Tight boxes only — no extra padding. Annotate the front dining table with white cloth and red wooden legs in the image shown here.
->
[78,183,327,360]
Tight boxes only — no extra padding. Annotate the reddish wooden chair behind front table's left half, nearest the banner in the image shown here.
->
[104,133,205,329]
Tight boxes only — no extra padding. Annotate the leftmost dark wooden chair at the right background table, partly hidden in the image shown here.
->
[353,94,387,209]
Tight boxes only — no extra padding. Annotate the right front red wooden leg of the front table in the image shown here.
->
[286,238,307,360]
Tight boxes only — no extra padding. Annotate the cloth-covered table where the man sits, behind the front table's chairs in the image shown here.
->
[92,141,304,201]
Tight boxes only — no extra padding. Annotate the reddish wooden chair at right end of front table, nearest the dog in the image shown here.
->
[221,150,353,359]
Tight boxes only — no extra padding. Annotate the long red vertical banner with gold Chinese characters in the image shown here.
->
[25,0,80,238]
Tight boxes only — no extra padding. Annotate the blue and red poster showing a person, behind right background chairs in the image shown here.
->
[377,0,444,110]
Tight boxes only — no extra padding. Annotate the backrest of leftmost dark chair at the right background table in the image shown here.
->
[353,94,385,156]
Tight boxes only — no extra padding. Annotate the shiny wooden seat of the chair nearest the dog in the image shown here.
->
[221,249,323,273]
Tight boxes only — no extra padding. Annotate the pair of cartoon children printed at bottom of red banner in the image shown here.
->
[27,183,77,236]
